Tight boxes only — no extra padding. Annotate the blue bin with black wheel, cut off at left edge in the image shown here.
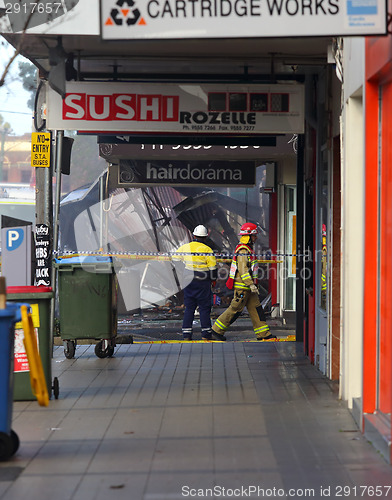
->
[0,302,24,461]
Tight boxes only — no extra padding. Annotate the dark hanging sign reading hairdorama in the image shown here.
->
[118,160,255,187]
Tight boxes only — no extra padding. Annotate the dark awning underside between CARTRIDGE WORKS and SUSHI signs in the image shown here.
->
[4,34,332,82]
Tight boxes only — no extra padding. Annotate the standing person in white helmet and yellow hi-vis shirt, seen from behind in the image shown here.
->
[173,225,217,340]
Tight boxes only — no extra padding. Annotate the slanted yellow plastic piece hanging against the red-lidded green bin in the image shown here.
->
[21,306,49,406]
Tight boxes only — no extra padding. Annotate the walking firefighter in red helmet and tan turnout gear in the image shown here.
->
[212,222,276,340]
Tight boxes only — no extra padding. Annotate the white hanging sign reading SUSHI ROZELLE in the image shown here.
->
[47,82,304,136]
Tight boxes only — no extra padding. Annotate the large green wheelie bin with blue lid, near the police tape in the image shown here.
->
[56,256,117,359]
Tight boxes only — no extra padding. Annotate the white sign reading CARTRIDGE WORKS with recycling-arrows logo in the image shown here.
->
[100,0,387,40]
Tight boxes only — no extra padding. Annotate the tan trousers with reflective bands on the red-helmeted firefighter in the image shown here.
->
[212,290,270,339]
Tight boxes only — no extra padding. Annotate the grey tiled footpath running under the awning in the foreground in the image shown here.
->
[0,342,392,500]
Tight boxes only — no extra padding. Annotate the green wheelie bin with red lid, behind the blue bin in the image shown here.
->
[7,286,59,401]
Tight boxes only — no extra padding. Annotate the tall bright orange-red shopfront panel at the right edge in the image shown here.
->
[363,35,392,434]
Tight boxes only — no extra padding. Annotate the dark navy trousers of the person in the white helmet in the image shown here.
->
[182,279,212,331]
